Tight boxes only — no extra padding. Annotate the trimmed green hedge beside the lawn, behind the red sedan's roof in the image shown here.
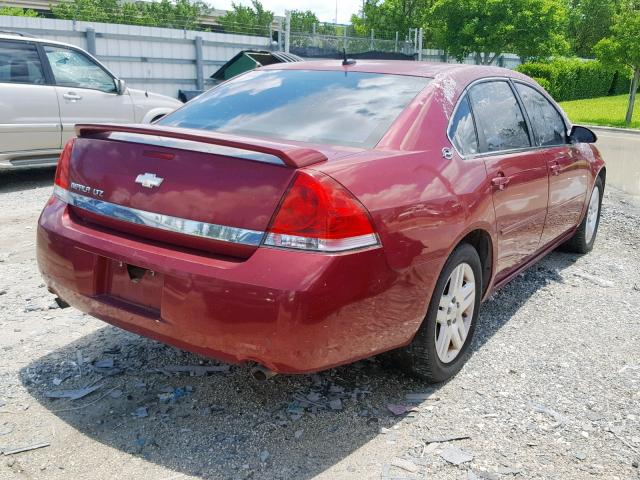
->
[516,58,630,102]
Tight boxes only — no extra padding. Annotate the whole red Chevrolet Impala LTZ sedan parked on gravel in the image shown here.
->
[37,61,605,381]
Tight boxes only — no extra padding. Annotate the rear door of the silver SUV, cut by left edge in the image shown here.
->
[0,40,60,153]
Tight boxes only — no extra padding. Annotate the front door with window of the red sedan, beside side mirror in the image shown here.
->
[515,82,589,245]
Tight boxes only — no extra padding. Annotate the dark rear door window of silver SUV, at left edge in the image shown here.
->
[0,41,45,85]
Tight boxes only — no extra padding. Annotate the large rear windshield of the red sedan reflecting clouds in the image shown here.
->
[158,70,430,148]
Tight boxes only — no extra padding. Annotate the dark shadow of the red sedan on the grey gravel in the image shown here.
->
[20,253,576,479]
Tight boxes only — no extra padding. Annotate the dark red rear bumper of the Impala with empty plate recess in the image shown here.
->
[37,198,434,373]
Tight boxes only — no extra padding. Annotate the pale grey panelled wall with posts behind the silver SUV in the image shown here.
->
[0,16,269,97]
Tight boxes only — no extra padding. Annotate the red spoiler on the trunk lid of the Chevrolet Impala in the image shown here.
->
[76,123,327,168]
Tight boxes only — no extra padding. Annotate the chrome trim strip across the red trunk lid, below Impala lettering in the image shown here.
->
[53,185,264,247]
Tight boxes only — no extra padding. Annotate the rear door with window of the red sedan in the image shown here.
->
[469,79,549,279]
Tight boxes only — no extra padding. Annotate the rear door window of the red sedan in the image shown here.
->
[469,81,531,152]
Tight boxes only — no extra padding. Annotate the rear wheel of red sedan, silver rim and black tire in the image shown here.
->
[392,244,482,382]
